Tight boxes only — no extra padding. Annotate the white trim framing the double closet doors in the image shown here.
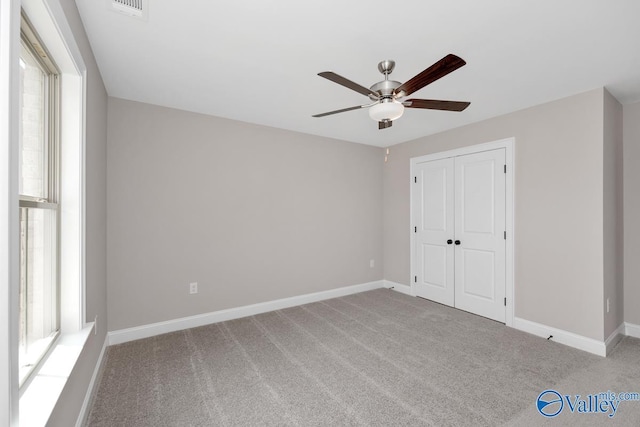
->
[409,138,516,327]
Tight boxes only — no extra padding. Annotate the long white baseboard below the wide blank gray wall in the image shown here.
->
[107,280,383,345]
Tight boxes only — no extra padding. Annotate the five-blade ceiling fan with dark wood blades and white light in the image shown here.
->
[313,54,470,129]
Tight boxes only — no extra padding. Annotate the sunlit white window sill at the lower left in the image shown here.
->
[20,322,94,427]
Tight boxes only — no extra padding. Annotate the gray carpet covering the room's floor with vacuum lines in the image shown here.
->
[87,289,640,426]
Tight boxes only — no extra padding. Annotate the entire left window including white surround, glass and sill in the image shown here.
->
[0,0,89,426]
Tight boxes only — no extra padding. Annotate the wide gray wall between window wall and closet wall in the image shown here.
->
[107,98,384,331]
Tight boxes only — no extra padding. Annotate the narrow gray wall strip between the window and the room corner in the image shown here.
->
[48,0,107,426]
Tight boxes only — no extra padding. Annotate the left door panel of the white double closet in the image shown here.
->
[412,158,455,306]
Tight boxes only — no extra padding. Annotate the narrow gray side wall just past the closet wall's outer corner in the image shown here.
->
[603,90,624,339]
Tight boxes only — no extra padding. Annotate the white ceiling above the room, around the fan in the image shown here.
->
[76,0,640,147]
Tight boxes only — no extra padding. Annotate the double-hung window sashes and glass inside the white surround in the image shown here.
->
[18,16,60,385]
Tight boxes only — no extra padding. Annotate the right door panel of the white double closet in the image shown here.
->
[455,149,506,322]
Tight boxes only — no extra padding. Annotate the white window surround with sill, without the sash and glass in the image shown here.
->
[0,0,89,427]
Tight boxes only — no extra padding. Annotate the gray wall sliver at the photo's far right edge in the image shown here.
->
[624,103,640,325]
